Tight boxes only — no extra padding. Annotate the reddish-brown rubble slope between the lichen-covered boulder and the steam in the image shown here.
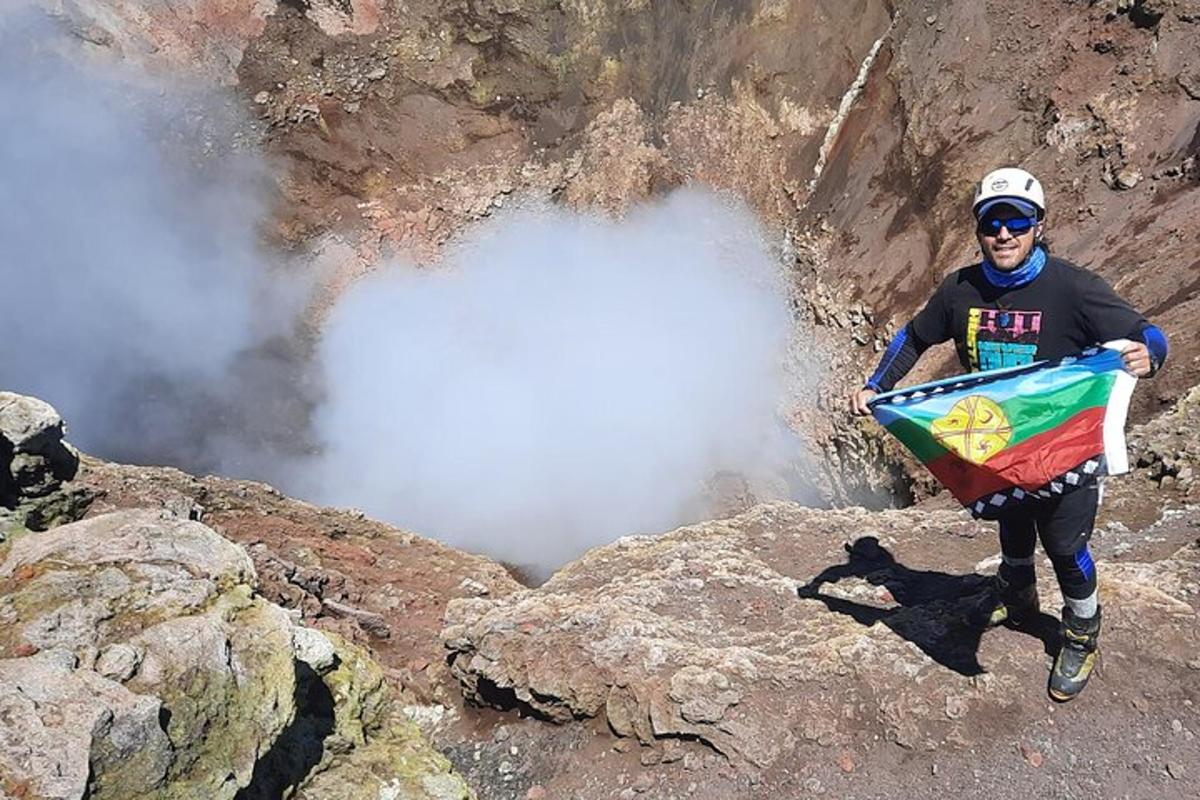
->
[73,456,521,705]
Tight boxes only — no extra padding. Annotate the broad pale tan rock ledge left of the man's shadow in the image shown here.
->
[443,506,944,764]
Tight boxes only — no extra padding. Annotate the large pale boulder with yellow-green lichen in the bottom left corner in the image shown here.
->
[0,510,469,800]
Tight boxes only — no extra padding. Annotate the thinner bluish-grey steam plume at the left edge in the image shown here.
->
[0,13,302,469]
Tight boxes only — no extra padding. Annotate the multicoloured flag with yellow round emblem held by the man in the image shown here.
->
[870,341,1138,518]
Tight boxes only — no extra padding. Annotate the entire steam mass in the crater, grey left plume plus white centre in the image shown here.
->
[0,14,804,575]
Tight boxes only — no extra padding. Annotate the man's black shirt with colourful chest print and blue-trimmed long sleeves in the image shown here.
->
[866,257,1166,392]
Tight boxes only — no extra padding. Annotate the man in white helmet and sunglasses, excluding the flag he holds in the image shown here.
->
[850,167,1166,702]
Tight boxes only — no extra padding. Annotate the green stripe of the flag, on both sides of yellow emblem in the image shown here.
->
[888,373,1116,464]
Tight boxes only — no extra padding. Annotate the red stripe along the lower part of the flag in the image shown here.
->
[925,405,1105,505]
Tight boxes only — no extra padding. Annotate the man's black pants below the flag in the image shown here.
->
[1000,485,1100,600]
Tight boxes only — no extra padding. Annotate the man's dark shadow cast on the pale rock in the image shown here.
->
[797,536,1060,676]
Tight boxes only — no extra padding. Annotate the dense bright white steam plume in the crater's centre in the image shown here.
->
[295,190,816,573]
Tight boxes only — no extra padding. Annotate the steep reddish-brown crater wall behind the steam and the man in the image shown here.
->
[37,0,1200,504]
